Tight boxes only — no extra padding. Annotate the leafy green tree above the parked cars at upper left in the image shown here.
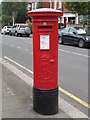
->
[2,2,28,24]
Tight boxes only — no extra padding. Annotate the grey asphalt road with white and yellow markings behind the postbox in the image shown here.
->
[0,35,90,114]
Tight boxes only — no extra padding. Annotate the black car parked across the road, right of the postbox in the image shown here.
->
[58,27,90,47]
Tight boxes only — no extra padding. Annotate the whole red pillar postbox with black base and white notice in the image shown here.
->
[28,8,63,115]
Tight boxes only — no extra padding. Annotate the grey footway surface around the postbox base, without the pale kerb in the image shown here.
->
[2,64,69,118]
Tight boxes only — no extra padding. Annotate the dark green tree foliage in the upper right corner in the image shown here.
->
[65,2,90,23]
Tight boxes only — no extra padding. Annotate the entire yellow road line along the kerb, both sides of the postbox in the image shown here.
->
[4,56,90,109]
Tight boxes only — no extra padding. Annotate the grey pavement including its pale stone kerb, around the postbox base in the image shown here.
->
[0,59,88,120]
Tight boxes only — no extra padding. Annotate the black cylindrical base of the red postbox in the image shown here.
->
[33,87,58,115]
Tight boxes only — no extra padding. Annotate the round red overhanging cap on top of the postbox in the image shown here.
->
[27,8,63,17]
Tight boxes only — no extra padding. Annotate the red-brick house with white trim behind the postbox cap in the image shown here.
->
[28,0,79,27]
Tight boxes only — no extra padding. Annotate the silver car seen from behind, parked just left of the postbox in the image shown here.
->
[10,24,31,37]
